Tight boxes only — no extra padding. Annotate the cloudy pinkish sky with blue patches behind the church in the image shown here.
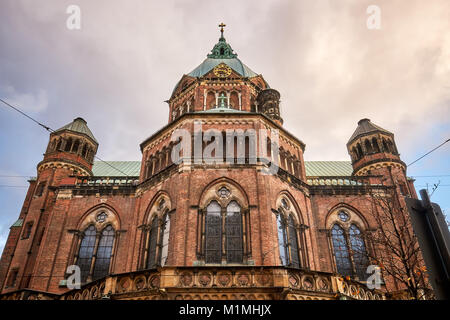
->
[0,0,450,252]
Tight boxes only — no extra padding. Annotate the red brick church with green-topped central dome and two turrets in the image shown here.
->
[0,25,417,300]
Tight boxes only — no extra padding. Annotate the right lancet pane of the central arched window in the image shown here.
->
[225,201,244,263]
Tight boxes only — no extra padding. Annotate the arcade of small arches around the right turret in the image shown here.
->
[350,136,398,162]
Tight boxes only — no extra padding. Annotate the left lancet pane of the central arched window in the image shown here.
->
[205,201,222,263]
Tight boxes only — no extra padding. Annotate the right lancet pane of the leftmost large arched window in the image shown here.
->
[92,225,114,280]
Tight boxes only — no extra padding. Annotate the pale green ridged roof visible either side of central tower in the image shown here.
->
[92,161,353,177]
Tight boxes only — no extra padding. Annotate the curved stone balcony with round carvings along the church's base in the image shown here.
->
[0,266,385,300]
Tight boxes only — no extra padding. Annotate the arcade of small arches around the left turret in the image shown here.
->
[47,136,95,162]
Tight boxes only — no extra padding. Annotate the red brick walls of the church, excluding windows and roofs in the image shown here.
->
[0,33,426,293]
